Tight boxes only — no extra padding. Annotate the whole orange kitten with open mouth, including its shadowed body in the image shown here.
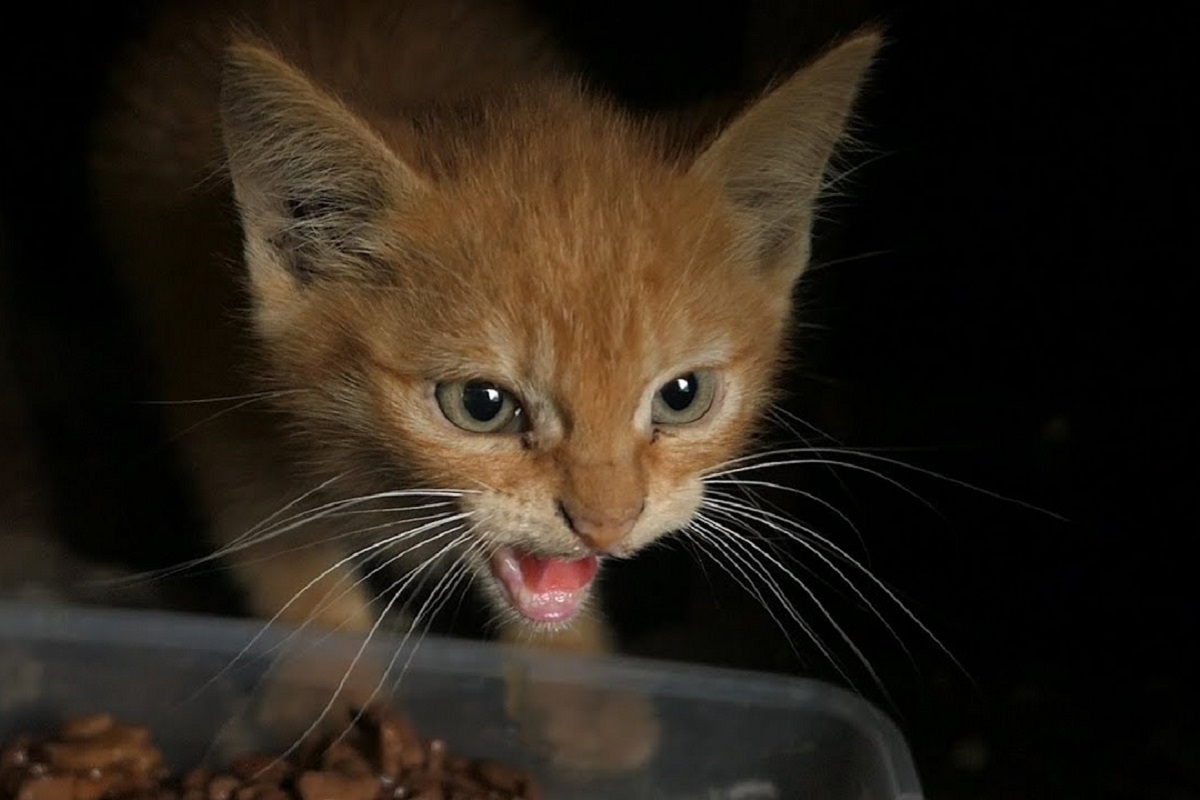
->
[94,0,880,777]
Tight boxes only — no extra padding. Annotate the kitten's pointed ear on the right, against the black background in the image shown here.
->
[691,30,882,287]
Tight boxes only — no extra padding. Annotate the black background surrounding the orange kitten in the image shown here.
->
[0,0,1200,798]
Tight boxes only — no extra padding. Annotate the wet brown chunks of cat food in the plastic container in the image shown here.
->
[0,705,541,800]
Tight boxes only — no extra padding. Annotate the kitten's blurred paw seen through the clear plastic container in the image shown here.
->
[505,673,661,774]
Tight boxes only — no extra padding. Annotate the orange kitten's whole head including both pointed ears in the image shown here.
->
[224,32,874,624]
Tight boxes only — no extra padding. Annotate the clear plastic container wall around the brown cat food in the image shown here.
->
[0,603,923,800]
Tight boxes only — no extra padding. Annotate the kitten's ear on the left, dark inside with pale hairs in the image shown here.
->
[221,41,424,297]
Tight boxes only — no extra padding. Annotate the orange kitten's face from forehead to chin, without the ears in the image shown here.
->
[264,130,787,621]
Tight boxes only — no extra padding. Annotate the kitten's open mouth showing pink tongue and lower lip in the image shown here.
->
[492,547,599,622]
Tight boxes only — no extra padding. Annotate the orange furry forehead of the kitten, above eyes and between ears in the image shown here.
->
[364,99,787,414]
